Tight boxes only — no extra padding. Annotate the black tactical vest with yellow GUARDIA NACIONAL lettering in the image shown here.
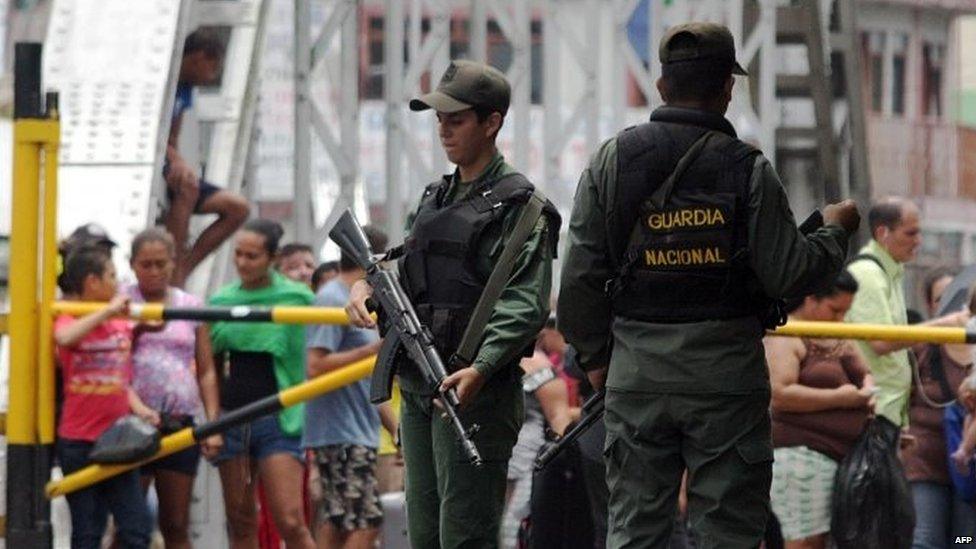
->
[607,110,770,323]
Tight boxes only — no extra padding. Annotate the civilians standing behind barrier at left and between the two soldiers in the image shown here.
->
[55,215,585,548]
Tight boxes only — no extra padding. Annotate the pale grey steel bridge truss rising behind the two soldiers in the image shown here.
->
[294,0,860,243]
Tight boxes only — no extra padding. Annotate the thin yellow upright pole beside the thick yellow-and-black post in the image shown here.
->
[36,104,61,445]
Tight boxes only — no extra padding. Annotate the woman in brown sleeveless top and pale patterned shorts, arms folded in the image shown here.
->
[765,271,875,549]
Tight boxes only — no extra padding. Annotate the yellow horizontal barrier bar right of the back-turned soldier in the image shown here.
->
[770,320,976,344]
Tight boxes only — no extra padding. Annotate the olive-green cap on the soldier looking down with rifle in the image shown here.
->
[410,60,512,116]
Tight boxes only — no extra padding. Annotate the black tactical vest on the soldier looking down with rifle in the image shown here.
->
[399,173,560,360]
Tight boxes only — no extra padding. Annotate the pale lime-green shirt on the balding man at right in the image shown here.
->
[846,239,912,426]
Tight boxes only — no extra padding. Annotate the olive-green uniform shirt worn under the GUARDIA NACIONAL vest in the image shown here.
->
[558,131,848,394]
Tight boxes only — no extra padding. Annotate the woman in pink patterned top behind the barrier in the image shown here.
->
[128,228,223,549]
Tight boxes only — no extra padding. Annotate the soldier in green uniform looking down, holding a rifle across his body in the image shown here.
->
[346,57,559,549]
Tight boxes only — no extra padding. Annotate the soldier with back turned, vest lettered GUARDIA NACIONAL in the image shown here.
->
[559,23,860,548]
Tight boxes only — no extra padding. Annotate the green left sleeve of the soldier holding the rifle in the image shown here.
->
[472,216,552,377]
